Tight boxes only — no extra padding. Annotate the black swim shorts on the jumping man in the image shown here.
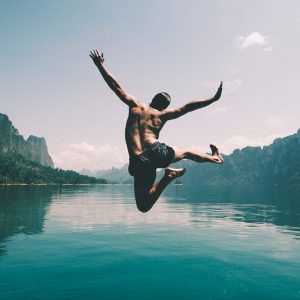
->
[128,142,175,187]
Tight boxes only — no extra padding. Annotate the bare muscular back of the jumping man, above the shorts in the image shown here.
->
[125,103,165,156]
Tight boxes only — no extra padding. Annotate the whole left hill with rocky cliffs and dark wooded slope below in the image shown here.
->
[0,114,107,184]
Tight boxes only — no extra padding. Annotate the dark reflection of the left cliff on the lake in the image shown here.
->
[0,186,57,255]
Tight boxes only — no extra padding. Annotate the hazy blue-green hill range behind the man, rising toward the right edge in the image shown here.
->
[85,129,300,186]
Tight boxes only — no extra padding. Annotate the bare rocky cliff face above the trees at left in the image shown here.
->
[0,113,53,167]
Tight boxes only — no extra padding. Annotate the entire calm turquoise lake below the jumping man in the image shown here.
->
[0,185,300,300]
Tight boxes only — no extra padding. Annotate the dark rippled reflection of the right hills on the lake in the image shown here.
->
[167,186,300,235]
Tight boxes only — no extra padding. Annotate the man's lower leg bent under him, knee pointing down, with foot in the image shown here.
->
[134,168,185,212]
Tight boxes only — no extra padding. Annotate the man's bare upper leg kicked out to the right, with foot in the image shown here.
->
[172,145,224,164]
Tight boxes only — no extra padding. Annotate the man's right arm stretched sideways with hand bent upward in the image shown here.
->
[161,82,223,120]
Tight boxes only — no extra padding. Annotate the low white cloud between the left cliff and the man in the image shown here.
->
[51,142,128,171]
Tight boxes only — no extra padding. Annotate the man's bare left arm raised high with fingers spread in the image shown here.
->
[90,49,138,107]
